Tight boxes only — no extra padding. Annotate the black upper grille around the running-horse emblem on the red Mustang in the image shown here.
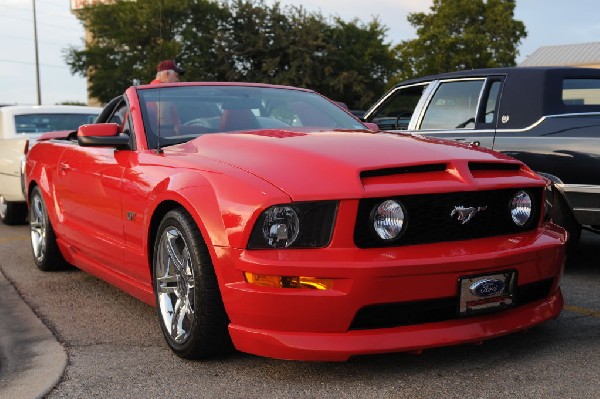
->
[354,188,542,248]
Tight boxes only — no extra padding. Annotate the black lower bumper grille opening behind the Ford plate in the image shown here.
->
[350,278,553,330]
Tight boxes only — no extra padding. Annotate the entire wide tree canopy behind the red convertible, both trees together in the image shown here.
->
[65,0,399,109]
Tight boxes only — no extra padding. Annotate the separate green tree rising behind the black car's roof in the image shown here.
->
[396,0,527,80]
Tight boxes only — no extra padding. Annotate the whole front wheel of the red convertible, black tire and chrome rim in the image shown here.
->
[152,208,231,359]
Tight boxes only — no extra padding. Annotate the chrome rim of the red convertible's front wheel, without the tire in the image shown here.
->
[154,226,196,344]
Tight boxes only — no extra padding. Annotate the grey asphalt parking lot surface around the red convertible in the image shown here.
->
[0,226,600,399]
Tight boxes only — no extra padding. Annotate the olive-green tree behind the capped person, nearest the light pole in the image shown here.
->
[65,0,224,102]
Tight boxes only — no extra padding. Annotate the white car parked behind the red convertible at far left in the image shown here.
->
[0,105,102,224]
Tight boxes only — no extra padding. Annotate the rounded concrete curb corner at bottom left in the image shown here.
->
[0,271,68,399]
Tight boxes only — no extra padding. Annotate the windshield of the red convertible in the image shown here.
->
[139,86,365,148]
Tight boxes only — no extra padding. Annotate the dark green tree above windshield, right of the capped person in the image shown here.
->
[211,0,398,109]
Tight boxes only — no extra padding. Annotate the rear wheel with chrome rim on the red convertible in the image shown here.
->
[29,187,67,271]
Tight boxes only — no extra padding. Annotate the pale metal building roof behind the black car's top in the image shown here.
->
[519,42,600,66]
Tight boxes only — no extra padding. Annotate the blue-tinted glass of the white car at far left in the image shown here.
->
[15,114,98,133]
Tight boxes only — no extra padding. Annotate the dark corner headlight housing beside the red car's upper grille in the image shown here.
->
[248,201,337,249]
